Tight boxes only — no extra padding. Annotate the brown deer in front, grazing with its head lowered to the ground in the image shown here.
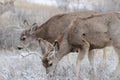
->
[42,12,120,75]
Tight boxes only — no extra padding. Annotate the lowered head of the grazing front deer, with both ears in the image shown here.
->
[18,38,55,74]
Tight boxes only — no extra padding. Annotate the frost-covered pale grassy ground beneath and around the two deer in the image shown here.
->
[0,47,120,80]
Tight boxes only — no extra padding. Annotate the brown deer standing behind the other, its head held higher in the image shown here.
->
[18,11,97,49]
